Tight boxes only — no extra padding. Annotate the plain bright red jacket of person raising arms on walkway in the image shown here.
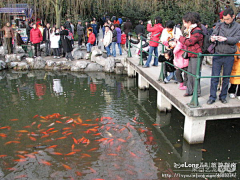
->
[147,24,164,47]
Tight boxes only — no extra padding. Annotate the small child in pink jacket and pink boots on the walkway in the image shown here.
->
[168,39,189,90]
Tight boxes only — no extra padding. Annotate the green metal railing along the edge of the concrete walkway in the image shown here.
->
[128,33,240,108]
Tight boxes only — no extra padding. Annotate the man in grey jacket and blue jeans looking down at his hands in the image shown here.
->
[207,8,240,104]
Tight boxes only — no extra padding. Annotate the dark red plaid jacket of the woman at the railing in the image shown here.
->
[179,27,203,57]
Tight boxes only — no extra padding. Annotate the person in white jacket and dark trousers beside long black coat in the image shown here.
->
[50,27,60,59]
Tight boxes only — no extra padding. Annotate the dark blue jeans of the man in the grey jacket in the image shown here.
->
[209,56,234,100]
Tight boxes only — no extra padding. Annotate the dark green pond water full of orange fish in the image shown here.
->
[0,71,240,180]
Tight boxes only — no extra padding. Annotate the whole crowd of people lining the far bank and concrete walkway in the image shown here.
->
[1,8,240,105]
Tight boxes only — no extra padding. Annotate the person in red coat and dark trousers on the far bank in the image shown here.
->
[30,24,43,57]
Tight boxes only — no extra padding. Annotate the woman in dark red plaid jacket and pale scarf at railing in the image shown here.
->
[176,12,203,97]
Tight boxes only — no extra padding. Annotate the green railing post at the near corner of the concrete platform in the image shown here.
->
[188,53,202,108]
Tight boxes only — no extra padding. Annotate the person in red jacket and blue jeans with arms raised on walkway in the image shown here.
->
[143,17,164,68]
